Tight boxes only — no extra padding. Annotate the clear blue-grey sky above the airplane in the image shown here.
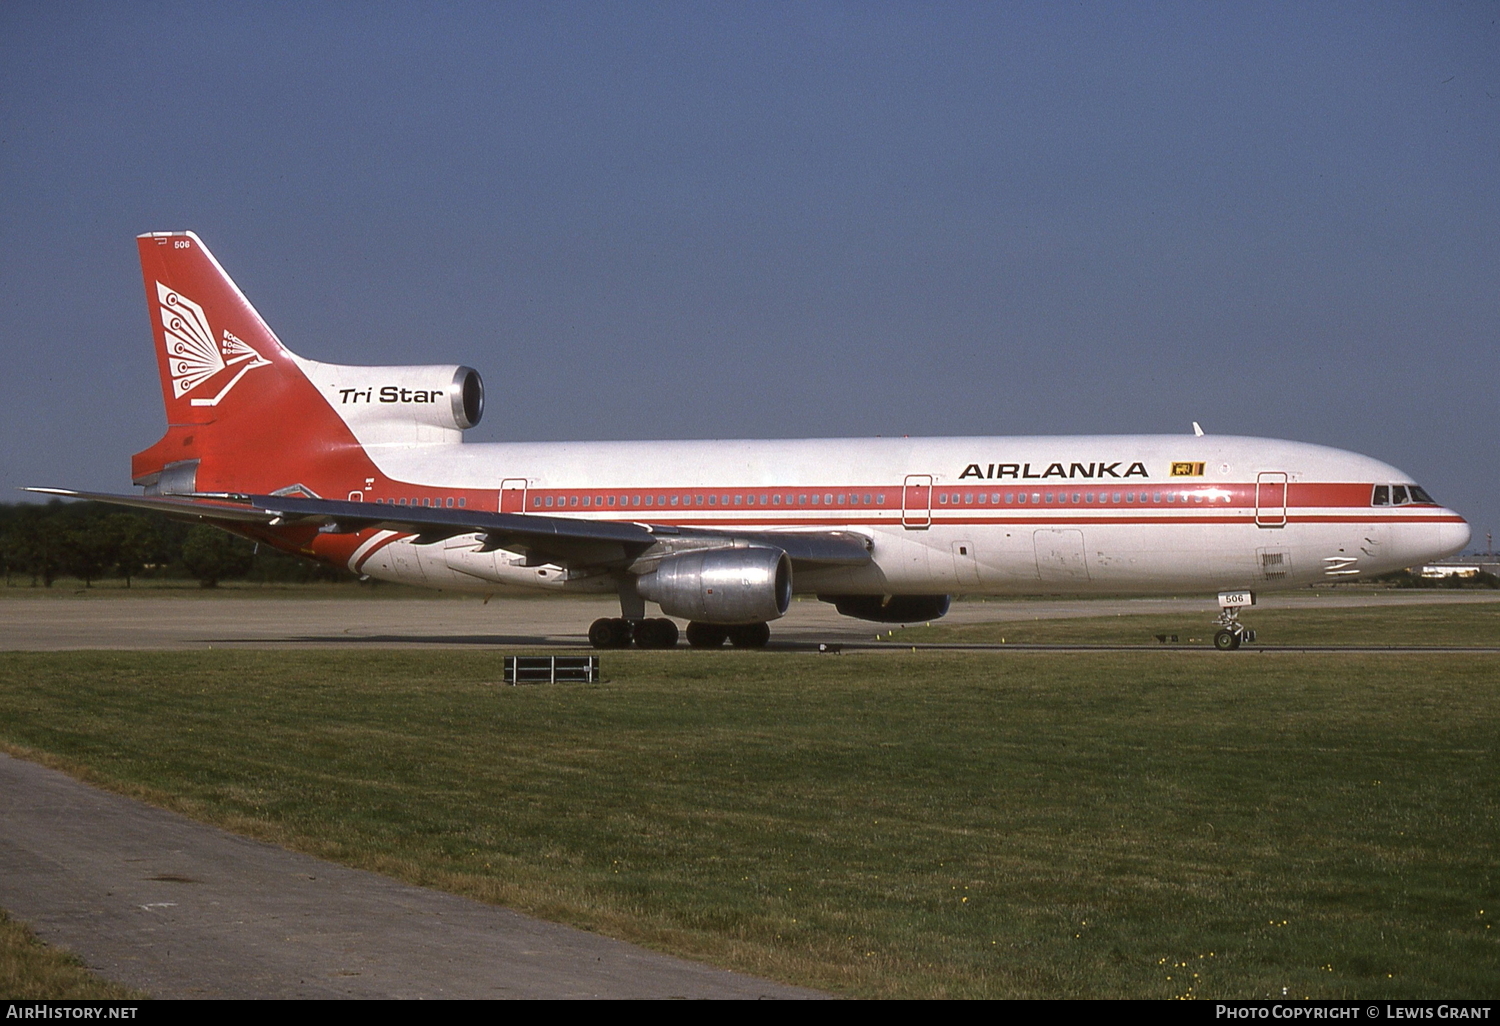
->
[0,2,1500,545]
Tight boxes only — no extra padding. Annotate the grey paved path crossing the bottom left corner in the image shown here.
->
[0,755,822,998]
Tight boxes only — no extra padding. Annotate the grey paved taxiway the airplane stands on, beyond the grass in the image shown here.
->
[0,588,1500,651]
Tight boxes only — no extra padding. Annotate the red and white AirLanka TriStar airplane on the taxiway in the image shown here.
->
[32,231,1470,650]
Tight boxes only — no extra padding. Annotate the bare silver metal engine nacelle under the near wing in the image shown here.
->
[636,549,792,624]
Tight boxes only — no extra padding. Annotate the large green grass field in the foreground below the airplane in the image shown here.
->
[0,651,1500,998]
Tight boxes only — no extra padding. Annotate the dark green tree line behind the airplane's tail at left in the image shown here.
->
[0,500,354,588]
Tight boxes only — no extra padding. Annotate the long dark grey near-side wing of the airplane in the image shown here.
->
[26,488,872,567]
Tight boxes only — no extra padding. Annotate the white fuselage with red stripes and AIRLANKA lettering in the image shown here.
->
[350,435,1469,594]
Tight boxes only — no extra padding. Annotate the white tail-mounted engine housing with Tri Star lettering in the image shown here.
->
[297,357,485,446]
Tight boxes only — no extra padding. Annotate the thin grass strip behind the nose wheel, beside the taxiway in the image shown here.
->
[890,596,1500,647]
